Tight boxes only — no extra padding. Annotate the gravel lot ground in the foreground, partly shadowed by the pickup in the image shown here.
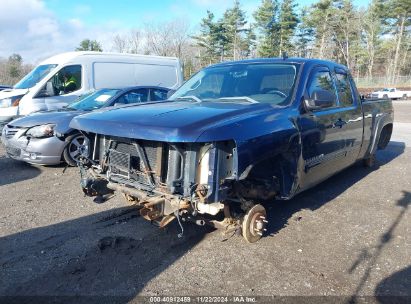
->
[0,101,411,303]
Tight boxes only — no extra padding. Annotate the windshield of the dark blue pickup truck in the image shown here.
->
[170,63,299,105]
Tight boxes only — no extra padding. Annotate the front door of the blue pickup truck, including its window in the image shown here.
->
[299,66,358,189]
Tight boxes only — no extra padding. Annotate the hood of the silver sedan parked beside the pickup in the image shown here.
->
[9,110,84,133]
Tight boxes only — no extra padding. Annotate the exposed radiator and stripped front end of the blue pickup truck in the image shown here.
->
[79,134,278,242]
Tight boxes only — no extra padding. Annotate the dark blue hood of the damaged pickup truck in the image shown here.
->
[70,102,279,142]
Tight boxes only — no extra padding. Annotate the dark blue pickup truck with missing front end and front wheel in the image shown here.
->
[71,58,393,243]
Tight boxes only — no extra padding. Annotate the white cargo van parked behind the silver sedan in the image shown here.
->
[0,52,183,124]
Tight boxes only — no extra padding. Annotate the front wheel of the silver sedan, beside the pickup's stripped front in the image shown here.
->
[63,133,90,167]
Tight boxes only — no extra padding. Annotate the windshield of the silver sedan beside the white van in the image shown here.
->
[67,89,120,111]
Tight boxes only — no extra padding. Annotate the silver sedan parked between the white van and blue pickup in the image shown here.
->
[1,86,169,166]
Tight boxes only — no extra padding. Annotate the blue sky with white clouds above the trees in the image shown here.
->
[0,0,369,63]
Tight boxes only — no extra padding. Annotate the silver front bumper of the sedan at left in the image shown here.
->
[1,126,64,165]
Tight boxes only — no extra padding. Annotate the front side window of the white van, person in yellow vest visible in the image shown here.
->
[43,65,81,96]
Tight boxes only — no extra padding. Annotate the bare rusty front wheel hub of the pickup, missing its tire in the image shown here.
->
[241,204,268,243]
